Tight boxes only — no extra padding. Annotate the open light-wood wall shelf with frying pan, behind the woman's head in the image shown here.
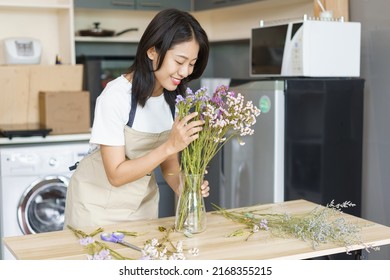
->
[74,0,313,44]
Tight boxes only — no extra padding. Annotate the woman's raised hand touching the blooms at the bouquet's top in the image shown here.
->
[168,112,205,153]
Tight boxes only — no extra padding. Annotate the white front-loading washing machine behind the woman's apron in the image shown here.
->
[0,142,89,260]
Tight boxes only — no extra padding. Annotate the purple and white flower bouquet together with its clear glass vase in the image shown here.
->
[175,86,260,234]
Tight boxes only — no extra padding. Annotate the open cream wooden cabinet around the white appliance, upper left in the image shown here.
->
[0,0,75,65]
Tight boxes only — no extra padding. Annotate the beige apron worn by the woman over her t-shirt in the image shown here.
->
[64,126,170,228]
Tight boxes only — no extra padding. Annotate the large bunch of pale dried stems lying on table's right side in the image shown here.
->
[213,201,378,253]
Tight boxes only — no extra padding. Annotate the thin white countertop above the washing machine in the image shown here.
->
[0,133,91,146]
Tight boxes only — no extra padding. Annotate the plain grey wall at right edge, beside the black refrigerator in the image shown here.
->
[350,0,390,259]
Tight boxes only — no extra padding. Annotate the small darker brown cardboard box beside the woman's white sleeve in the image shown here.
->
[39,91,90,134]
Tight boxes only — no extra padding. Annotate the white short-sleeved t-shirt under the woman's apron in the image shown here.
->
[90,75,173,146]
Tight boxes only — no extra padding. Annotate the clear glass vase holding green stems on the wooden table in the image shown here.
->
[175,173,206,234]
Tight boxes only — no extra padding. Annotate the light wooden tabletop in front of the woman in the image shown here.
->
[4,200,390,260]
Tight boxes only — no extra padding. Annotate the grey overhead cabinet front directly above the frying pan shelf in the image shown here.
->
[75,0,191,11]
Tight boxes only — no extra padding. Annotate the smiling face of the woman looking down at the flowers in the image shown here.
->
[148,40,199,96]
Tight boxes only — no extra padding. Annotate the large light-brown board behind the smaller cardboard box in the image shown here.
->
[0,65,83,125]
